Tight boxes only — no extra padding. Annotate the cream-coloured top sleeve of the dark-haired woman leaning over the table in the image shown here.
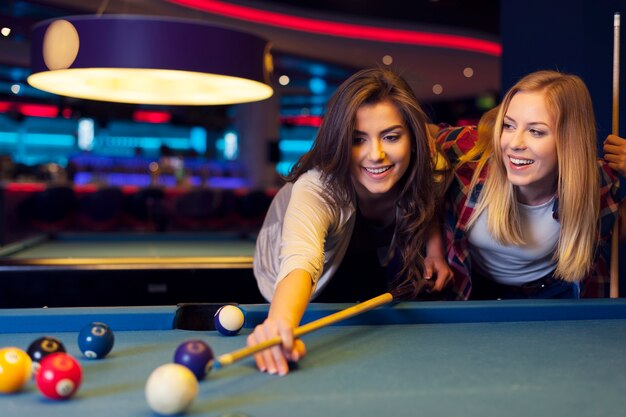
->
[253,170,356,301]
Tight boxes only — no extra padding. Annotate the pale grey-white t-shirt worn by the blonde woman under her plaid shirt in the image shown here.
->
[468,198,561,286]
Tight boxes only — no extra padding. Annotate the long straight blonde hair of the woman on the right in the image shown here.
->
[468,71,600,282]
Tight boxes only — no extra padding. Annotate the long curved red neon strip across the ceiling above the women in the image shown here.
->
[167,0,502,56]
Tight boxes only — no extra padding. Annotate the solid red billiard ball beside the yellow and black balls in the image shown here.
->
[36,353,83,400]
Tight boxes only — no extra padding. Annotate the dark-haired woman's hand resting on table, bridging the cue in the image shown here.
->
[247,318,306,375]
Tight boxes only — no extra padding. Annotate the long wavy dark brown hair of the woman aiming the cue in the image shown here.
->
[287,68,443,289]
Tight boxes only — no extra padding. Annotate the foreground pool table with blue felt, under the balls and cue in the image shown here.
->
[0,299,626,417]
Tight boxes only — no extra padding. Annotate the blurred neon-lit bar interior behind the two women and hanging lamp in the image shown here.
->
[0,0,626,308]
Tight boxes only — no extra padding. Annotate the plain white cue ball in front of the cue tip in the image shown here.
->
[146,363,198,415]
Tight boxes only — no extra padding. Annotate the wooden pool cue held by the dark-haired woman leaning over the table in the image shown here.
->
[213,285,414,369]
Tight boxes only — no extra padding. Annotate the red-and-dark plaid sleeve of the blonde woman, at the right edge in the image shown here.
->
[581,160,619,298]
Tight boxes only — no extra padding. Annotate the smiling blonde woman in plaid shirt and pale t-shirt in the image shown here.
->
[438,71,618,299]
